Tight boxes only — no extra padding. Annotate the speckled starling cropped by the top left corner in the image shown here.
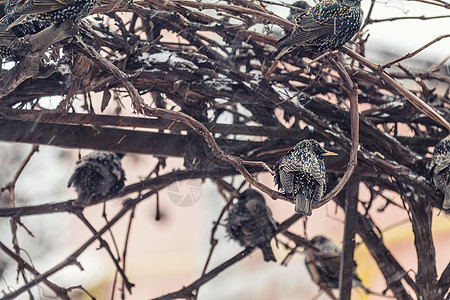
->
[3,0,99,37]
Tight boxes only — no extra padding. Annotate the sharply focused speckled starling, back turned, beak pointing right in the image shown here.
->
[274,139,337,216]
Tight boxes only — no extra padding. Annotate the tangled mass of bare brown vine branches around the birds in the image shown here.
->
[0,0,450,299]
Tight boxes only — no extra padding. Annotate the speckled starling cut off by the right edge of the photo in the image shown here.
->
[429,135,450,209]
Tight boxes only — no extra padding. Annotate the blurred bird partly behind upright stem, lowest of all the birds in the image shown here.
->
[305,235,370,292]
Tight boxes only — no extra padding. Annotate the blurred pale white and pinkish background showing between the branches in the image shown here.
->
[0,0,450,300]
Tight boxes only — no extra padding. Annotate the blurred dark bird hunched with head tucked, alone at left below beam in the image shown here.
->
[67,151,125,206]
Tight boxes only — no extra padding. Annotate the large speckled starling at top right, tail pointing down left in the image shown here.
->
[275,0,363,59]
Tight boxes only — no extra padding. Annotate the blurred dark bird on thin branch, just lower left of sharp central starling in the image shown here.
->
[227,189,277,261]
